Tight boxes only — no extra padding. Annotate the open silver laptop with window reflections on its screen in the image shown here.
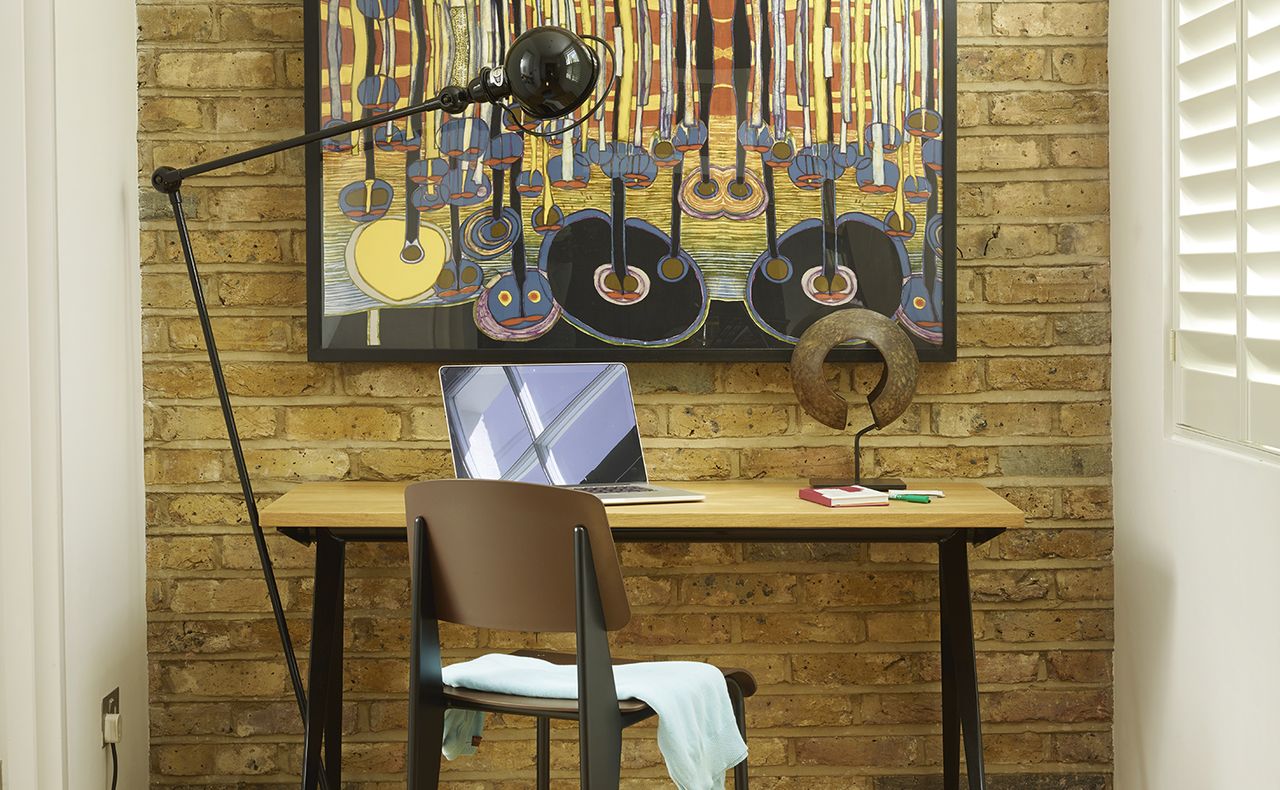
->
[440,362,705,504]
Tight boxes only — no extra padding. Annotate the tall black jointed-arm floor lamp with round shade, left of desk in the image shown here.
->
[151,27,613,790]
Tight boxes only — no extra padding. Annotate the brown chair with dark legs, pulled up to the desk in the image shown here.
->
[404,480,755,790]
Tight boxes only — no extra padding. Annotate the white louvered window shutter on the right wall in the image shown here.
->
[1174,0,1280,449]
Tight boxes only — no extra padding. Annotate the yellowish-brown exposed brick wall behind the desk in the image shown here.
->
[138,0,1112,790]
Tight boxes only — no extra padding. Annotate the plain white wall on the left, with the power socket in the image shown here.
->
[0,0,148,790]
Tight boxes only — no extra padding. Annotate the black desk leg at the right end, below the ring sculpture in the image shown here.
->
[938,531,987,790]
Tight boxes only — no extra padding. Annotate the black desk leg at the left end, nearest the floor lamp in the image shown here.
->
[302,531,347,790]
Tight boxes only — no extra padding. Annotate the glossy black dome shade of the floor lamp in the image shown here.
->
[503,26,599,119]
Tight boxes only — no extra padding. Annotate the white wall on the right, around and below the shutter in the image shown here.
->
[1110,0,1280,790]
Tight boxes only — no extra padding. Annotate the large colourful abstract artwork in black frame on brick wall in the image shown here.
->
[306,0,956,361]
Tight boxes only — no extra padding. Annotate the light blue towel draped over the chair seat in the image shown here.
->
[443,653,746,790]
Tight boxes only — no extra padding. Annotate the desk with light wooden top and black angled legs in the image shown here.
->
[261,480,1023,790]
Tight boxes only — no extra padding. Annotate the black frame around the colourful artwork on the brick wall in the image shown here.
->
[303,0,957,362]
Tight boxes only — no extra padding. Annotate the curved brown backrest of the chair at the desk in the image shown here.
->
[404,480,631,633]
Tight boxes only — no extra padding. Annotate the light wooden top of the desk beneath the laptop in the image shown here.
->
[261,479,1023,534]
